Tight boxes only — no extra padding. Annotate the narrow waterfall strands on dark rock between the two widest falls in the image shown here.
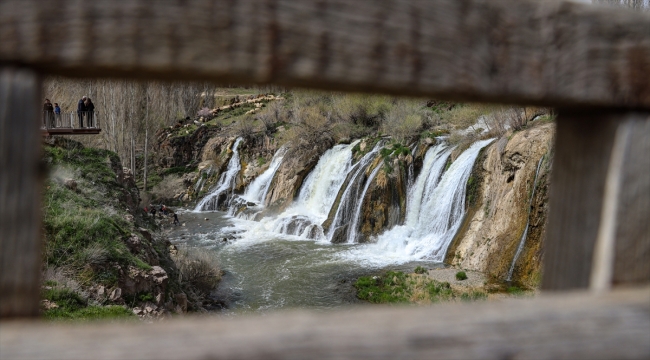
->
[327,141,383,242]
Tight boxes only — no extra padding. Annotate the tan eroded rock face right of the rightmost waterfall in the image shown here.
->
[446,124,555,285]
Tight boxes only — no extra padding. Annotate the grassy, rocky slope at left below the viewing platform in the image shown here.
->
[43,139,220,319]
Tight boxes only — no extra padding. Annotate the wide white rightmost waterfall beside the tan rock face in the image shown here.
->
[342,139,493,265]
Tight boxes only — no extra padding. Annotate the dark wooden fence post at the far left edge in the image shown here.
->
[0,66,43,318]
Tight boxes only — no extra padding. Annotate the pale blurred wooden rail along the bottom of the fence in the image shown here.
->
[0,288,650,360]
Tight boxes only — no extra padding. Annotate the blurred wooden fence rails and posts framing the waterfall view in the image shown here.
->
[0,0,650,359]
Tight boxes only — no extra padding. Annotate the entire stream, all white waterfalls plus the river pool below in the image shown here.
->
[177,139,492,314]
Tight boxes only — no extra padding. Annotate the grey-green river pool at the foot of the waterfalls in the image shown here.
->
[170,211,442,315]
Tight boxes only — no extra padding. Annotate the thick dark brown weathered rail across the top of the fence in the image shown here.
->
[0,0,650,108]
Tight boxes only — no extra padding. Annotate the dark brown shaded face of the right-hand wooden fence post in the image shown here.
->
[542,109,624,290]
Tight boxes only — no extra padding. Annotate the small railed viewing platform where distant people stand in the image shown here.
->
[41,111,101,136]
